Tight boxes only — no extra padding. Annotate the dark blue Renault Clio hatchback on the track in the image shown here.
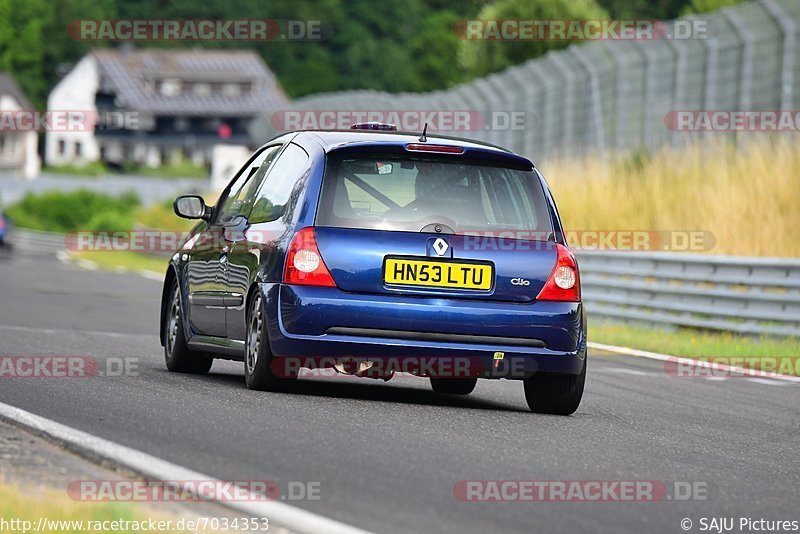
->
[161,129,586,414]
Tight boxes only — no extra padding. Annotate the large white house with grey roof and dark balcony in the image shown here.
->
[45,46,287,171]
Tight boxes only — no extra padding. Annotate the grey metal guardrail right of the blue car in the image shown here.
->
[578,251,800,336]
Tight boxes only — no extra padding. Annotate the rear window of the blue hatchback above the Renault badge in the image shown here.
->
[315,154,553,233]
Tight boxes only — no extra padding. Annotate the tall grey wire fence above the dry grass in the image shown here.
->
[259,0,800,159]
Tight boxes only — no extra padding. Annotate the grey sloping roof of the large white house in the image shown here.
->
[92,48,287,116]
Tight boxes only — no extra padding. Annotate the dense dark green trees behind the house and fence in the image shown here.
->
[0,0,741,109]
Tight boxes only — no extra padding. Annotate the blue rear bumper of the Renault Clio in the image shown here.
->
[262,284,586,378]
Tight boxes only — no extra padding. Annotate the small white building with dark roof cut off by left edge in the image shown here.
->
[0,73,41,179]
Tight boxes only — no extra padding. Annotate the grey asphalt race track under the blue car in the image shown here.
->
[0,249,800,533]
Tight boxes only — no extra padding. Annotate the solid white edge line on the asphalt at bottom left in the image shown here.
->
[0,402,369,534]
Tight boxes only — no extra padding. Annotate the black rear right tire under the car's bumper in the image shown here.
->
[523,360,586,415]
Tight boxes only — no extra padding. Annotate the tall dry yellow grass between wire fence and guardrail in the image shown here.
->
[539,136,800,257]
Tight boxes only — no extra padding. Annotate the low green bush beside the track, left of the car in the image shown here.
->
[6,189,139,236]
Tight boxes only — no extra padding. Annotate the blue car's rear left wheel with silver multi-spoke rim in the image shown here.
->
[244,291,295,391]
